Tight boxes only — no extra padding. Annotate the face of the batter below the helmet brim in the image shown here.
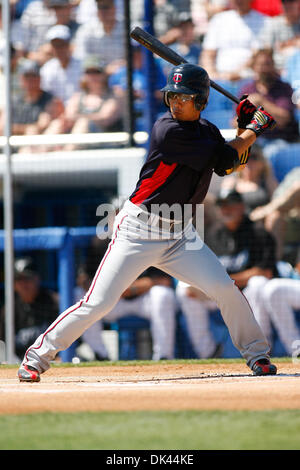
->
[168,93,200,121]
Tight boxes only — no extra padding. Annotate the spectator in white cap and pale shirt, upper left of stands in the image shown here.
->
[41,25,82,105]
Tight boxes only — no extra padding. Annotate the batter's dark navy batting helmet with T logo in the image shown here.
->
[160,64,210,110]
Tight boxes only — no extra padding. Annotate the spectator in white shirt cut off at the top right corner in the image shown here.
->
[259,0,300,73]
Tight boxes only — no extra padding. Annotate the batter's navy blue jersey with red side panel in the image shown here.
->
[129,111,238,212]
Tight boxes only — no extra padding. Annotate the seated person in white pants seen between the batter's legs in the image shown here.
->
[77,238,177,360]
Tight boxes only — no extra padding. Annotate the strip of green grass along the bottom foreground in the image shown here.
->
[0,410,300,450]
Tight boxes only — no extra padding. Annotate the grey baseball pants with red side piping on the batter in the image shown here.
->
[23,201,269,373]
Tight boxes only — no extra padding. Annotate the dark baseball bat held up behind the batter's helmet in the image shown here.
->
[130,26,240,104]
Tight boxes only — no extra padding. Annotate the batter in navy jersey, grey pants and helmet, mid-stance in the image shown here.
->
[18,63,277,382]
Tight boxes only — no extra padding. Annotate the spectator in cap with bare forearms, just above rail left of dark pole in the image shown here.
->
[51,56,123,150]
